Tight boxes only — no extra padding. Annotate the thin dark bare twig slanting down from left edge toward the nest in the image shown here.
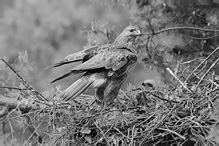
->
[1,59,48,101]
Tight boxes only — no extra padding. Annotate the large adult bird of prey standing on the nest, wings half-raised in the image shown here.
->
[49,26,141,105]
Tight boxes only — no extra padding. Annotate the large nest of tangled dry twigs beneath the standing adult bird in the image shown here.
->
[45,82,218,145]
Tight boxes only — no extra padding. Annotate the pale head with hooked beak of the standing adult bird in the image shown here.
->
[115,26,141,43]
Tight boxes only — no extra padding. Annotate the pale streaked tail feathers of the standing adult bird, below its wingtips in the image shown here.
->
[58,78,93,101]
